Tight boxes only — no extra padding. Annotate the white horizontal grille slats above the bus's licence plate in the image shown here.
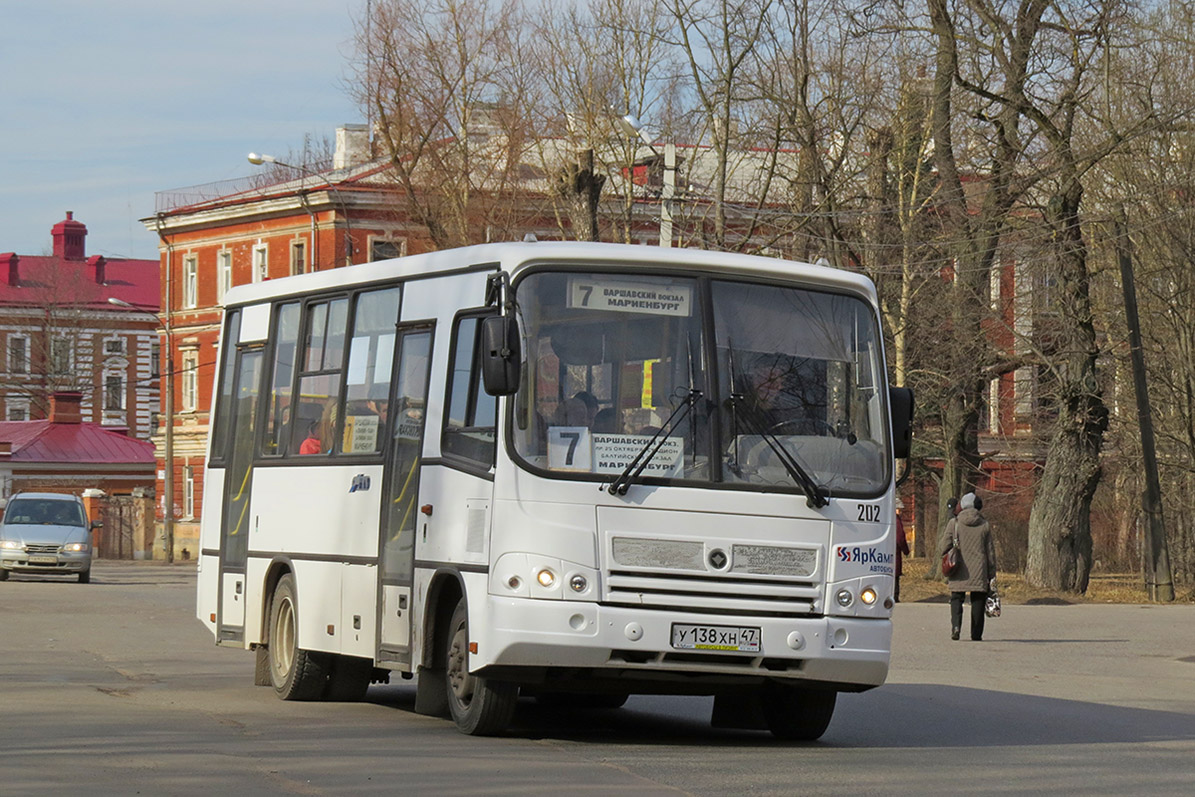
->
[603,570,820,615]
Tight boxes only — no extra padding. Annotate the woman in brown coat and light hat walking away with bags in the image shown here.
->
[938,492,995,642]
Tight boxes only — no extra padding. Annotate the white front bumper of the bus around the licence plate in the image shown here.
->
[470,595,891,689]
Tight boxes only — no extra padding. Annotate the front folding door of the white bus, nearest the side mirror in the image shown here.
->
[376,325,431,666]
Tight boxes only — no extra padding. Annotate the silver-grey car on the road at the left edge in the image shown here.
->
[0,492,99,584]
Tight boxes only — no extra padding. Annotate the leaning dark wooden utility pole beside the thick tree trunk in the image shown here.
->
[1116,215,1175,601]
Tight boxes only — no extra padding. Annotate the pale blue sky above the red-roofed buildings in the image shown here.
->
[0,0,366,259]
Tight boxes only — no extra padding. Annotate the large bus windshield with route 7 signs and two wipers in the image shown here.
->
[513,271,890,497]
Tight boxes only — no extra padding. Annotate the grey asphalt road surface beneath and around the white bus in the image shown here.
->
[0,562,1195,796]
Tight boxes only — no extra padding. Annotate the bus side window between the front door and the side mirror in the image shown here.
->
[441,315,498,467]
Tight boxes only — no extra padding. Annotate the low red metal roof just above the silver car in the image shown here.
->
[0,421,155,465]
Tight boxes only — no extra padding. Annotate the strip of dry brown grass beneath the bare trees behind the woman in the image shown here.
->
[900,558,1195,605]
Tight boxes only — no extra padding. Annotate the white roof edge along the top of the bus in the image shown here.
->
[223,241,876,306]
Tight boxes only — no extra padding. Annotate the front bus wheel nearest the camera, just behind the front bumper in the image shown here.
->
[445,597,519,736]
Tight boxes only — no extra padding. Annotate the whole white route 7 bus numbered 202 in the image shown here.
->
[197,243,912,740]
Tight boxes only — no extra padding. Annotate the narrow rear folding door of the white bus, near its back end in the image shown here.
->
[216,349,262,640]
